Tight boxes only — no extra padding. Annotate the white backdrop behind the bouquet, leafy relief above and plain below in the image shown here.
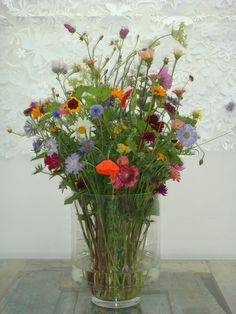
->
[0,0,236,258]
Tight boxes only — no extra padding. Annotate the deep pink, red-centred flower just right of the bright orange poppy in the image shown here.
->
[110,165,138,190]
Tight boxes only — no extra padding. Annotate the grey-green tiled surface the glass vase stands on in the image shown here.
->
[0,260,236,314]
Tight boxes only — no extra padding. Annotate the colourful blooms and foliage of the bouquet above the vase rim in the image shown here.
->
[9,23,201,203]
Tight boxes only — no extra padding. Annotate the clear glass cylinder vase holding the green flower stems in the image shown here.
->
[72,193,160,308]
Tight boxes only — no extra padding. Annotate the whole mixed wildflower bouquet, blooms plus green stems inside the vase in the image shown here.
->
[9,23,201,299]
